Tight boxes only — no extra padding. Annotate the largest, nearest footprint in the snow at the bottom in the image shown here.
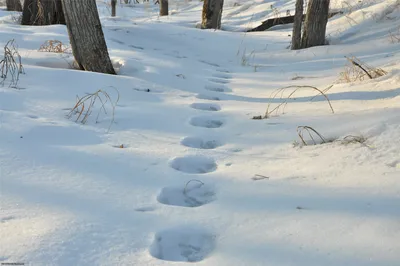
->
[150,226,215,262]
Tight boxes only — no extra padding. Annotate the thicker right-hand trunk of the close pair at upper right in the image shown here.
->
[301,0,330,48]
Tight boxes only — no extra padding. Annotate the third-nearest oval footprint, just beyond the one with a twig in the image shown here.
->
[170,155,217,174]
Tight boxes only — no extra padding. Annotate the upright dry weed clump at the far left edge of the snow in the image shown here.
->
[0,39,24,88]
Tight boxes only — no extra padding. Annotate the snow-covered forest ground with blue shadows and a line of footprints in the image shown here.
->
[0,0,400,266]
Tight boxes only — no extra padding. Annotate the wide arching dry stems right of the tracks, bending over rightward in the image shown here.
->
[263,85,335,118]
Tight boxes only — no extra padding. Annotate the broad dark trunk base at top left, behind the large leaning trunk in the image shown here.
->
[21,0,65,26]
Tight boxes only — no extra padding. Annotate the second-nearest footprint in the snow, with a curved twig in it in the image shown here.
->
[157,180,215,207]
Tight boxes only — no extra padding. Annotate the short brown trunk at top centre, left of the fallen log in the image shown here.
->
[201,0,224,29]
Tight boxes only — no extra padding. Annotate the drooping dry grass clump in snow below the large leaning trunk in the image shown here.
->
[67,87,119,130]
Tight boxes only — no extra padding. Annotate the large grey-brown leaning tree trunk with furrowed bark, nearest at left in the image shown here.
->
[62,0,116,74]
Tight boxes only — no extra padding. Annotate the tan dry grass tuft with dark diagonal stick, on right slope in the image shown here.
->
[338,57,387,83]
